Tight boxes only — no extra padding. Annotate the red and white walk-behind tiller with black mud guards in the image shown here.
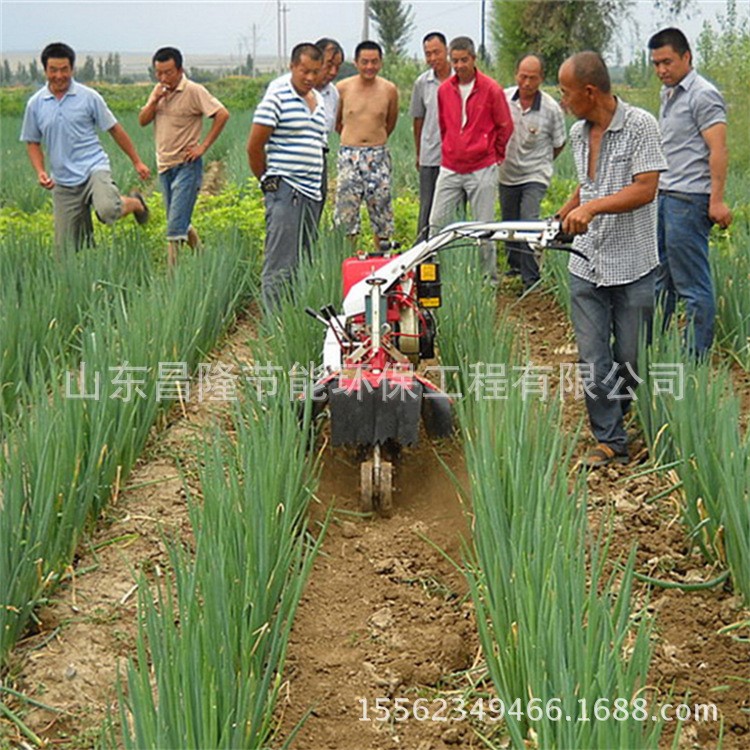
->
[306,220,574,516]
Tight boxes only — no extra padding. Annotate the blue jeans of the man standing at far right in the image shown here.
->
[656,192,716,357]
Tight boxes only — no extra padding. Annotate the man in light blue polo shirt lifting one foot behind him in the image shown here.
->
[21,42,150,249]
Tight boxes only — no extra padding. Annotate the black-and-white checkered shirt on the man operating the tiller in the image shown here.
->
[568,99,667,286]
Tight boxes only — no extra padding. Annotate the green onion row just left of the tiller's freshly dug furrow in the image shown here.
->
[104,234,348,750]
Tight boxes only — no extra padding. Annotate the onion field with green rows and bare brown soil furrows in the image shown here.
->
[0,55,750,750]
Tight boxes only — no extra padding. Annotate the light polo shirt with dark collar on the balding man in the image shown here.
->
[499,86,565,187]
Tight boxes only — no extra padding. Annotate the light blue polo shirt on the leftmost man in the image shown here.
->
[21,79,117,187]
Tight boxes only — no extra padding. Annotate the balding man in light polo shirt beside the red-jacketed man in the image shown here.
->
[499,55,565,290]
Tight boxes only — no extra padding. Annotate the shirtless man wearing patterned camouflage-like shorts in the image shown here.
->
[334,41,398,248]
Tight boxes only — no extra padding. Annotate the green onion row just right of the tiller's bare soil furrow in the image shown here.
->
[440,250,661,748]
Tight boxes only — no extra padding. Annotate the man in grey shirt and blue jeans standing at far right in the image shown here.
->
[648,28,732,357]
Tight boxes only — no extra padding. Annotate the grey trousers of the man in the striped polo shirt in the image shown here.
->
[260,179,323,311]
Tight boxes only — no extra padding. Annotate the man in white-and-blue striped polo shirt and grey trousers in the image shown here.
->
[247,43,326,312]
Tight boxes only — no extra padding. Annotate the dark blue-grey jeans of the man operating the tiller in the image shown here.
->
[570,270,656,454]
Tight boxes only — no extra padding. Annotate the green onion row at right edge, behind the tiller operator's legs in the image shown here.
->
[636,322,750,604]
